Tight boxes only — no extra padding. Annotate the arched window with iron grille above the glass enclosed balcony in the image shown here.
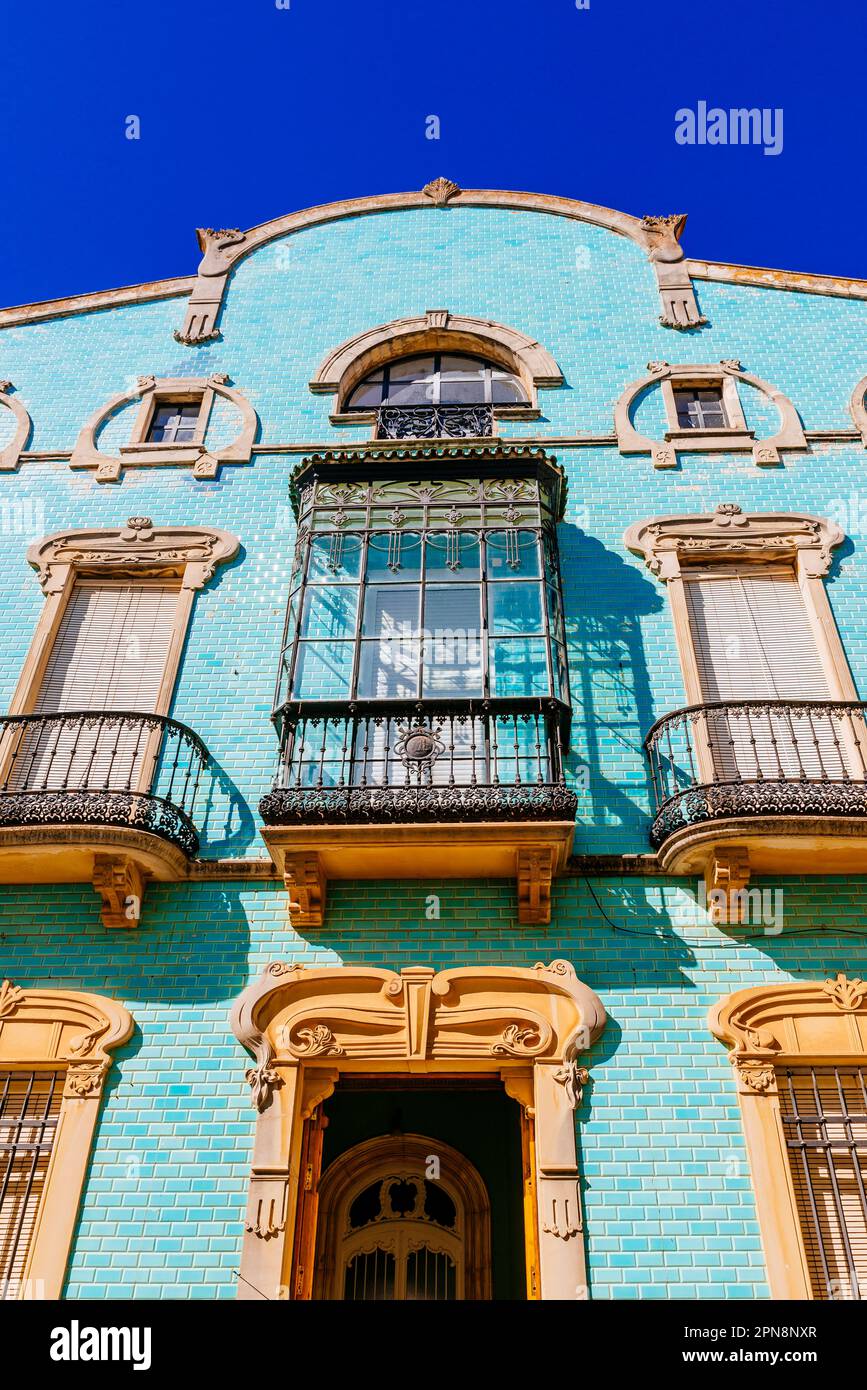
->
[346,353,527,439]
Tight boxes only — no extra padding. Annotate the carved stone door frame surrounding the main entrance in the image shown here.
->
[232,960,606,1300]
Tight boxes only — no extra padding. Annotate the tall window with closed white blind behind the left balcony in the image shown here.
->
[13,581,178,790]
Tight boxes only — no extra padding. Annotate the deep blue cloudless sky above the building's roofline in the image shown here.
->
[0,0,867,304]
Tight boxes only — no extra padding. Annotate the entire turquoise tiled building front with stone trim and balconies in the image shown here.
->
[0,179,867,1300]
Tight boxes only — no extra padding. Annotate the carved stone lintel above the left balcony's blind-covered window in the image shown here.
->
[26,517,240,594]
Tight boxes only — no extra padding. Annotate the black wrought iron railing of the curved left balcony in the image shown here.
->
[0,710,210,858]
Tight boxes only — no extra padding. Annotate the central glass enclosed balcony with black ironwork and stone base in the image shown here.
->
[260,446,577,922]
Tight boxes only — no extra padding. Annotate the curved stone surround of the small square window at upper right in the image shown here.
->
[614,360,809,468]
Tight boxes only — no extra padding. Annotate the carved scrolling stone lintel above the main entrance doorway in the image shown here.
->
[232,960,604,1109]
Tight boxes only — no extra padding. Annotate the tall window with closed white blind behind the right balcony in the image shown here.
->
[684,567,860,780]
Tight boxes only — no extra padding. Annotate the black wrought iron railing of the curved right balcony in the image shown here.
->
[645,699,867,847]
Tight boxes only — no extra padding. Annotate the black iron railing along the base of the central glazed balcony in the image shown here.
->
[260,699,578,826]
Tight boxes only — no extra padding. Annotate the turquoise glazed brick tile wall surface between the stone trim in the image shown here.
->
[0,190,867,1298]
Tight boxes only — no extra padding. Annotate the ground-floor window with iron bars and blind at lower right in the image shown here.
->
[777,1066,867,1298]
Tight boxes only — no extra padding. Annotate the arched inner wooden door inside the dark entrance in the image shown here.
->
[315,1134,490,1302]
